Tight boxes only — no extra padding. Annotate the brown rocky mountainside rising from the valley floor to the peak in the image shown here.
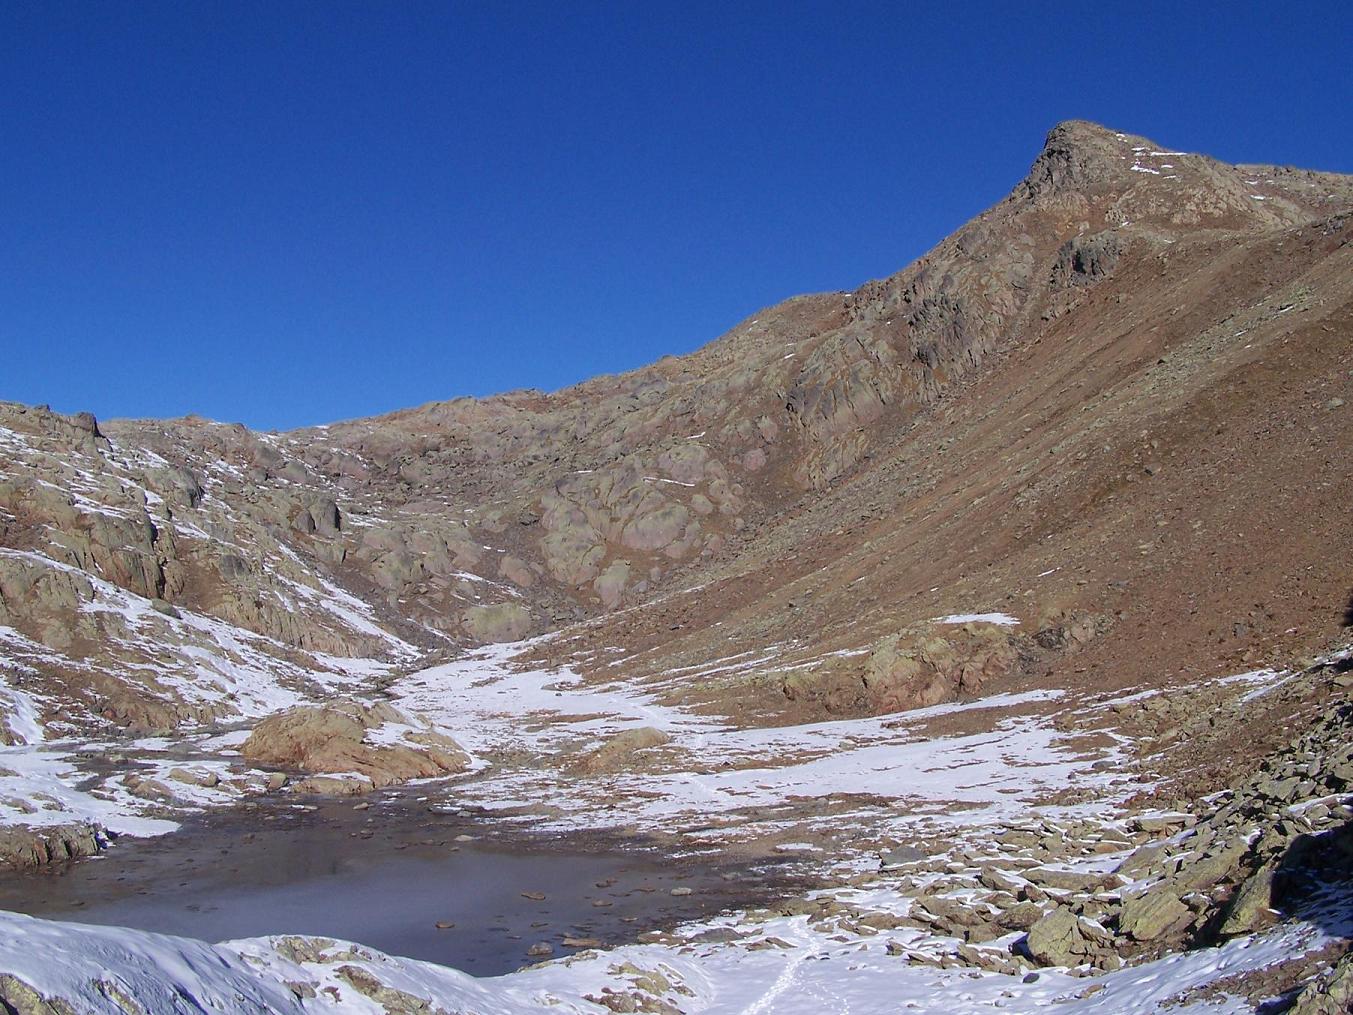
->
[0,122,1353,729]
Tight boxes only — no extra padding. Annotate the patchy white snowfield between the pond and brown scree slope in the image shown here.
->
[390,644,1126,838]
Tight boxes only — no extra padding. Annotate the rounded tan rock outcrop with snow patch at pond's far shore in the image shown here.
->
[241,702,469,793]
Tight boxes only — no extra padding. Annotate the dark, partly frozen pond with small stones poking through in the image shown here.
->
[0,796,789,974]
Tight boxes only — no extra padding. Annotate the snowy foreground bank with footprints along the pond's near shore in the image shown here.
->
[0,876,1353,1015]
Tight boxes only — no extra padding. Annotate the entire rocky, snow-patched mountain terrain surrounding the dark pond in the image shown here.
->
[0,122,1353,1012]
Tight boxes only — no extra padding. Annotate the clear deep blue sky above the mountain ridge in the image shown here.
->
[0,0,1353,428]
